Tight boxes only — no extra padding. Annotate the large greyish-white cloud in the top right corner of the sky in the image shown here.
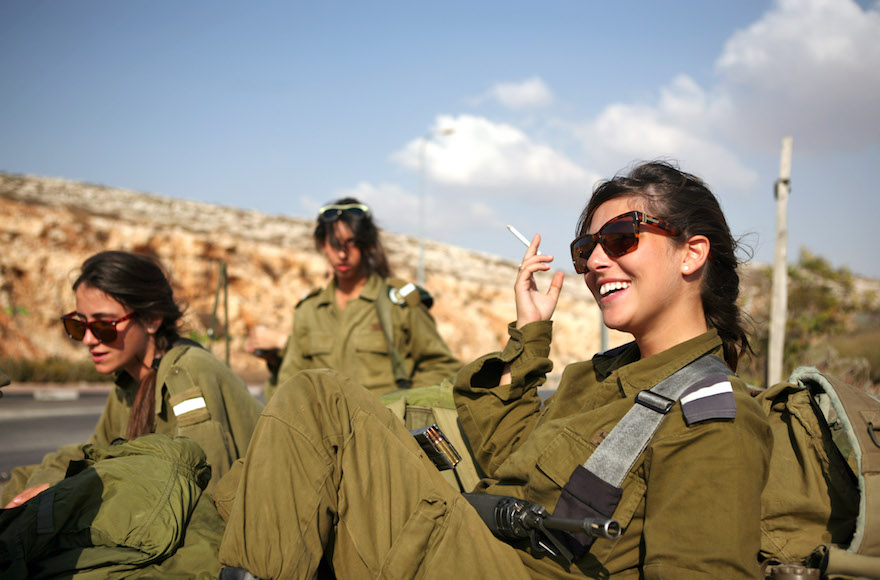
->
[716,0,880,152]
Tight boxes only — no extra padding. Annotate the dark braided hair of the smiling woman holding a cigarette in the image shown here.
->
[576,161,751,371]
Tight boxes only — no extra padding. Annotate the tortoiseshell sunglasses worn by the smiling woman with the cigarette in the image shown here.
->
[571,211,681,274]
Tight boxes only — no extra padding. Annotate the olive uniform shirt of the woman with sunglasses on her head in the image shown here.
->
[266,274,461,401]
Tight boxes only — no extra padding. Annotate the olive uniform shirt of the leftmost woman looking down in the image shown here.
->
[0,340,263,505]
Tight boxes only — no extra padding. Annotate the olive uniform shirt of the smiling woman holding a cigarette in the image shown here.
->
[455,321,771,578]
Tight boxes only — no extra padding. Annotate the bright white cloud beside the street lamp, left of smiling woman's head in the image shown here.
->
[392,115,592,190]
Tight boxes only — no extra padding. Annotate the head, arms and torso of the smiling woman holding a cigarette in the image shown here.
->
[456,162,771,578]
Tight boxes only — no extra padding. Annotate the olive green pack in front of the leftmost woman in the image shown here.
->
[0,433,224,580]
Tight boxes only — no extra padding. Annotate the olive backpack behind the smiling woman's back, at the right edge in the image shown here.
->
[756,367,880,579]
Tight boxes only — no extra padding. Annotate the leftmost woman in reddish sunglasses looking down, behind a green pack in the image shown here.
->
[2,251,262,505]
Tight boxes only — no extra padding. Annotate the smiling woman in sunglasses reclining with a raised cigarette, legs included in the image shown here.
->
[220,163,771,579]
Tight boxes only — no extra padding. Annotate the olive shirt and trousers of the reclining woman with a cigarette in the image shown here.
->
[220,322,770,579]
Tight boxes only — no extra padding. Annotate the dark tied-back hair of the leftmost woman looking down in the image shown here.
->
[73,251,183,439]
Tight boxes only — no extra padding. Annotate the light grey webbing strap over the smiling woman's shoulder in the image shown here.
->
[584,355,730,487]
